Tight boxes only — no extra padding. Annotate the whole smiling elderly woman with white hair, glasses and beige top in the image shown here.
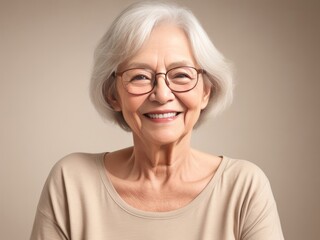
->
[31,2,283,240]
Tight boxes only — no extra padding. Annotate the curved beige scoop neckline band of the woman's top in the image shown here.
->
[97,153,228,219]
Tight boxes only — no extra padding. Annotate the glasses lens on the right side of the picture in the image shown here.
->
[167,67,198,92]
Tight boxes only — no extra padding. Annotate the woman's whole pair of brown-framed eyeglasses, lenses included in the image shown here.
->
[114,66,206,95]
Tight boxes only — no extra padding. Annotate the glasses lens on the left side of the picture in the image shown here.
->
[122,68,154,94]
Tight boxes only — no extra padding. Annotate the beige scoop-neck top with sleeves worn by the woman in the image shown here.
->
[31,153,284,240]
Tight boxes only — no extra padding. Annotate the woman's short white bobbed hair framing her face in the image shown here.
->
[90,2,233,131]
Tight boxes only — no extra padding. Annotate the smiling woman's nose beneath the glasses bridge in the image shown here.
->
[150,73,175,104]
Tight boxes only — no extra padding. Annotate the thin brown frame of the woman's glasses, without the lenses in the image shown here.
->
[113,66,206,95]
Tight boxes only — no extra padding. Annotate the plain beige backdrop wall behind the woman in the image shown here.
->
[0,0,320,240]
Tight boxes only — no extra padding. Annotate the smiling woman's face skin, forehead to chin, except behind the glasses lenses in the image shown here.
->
[114,24,210,145]
